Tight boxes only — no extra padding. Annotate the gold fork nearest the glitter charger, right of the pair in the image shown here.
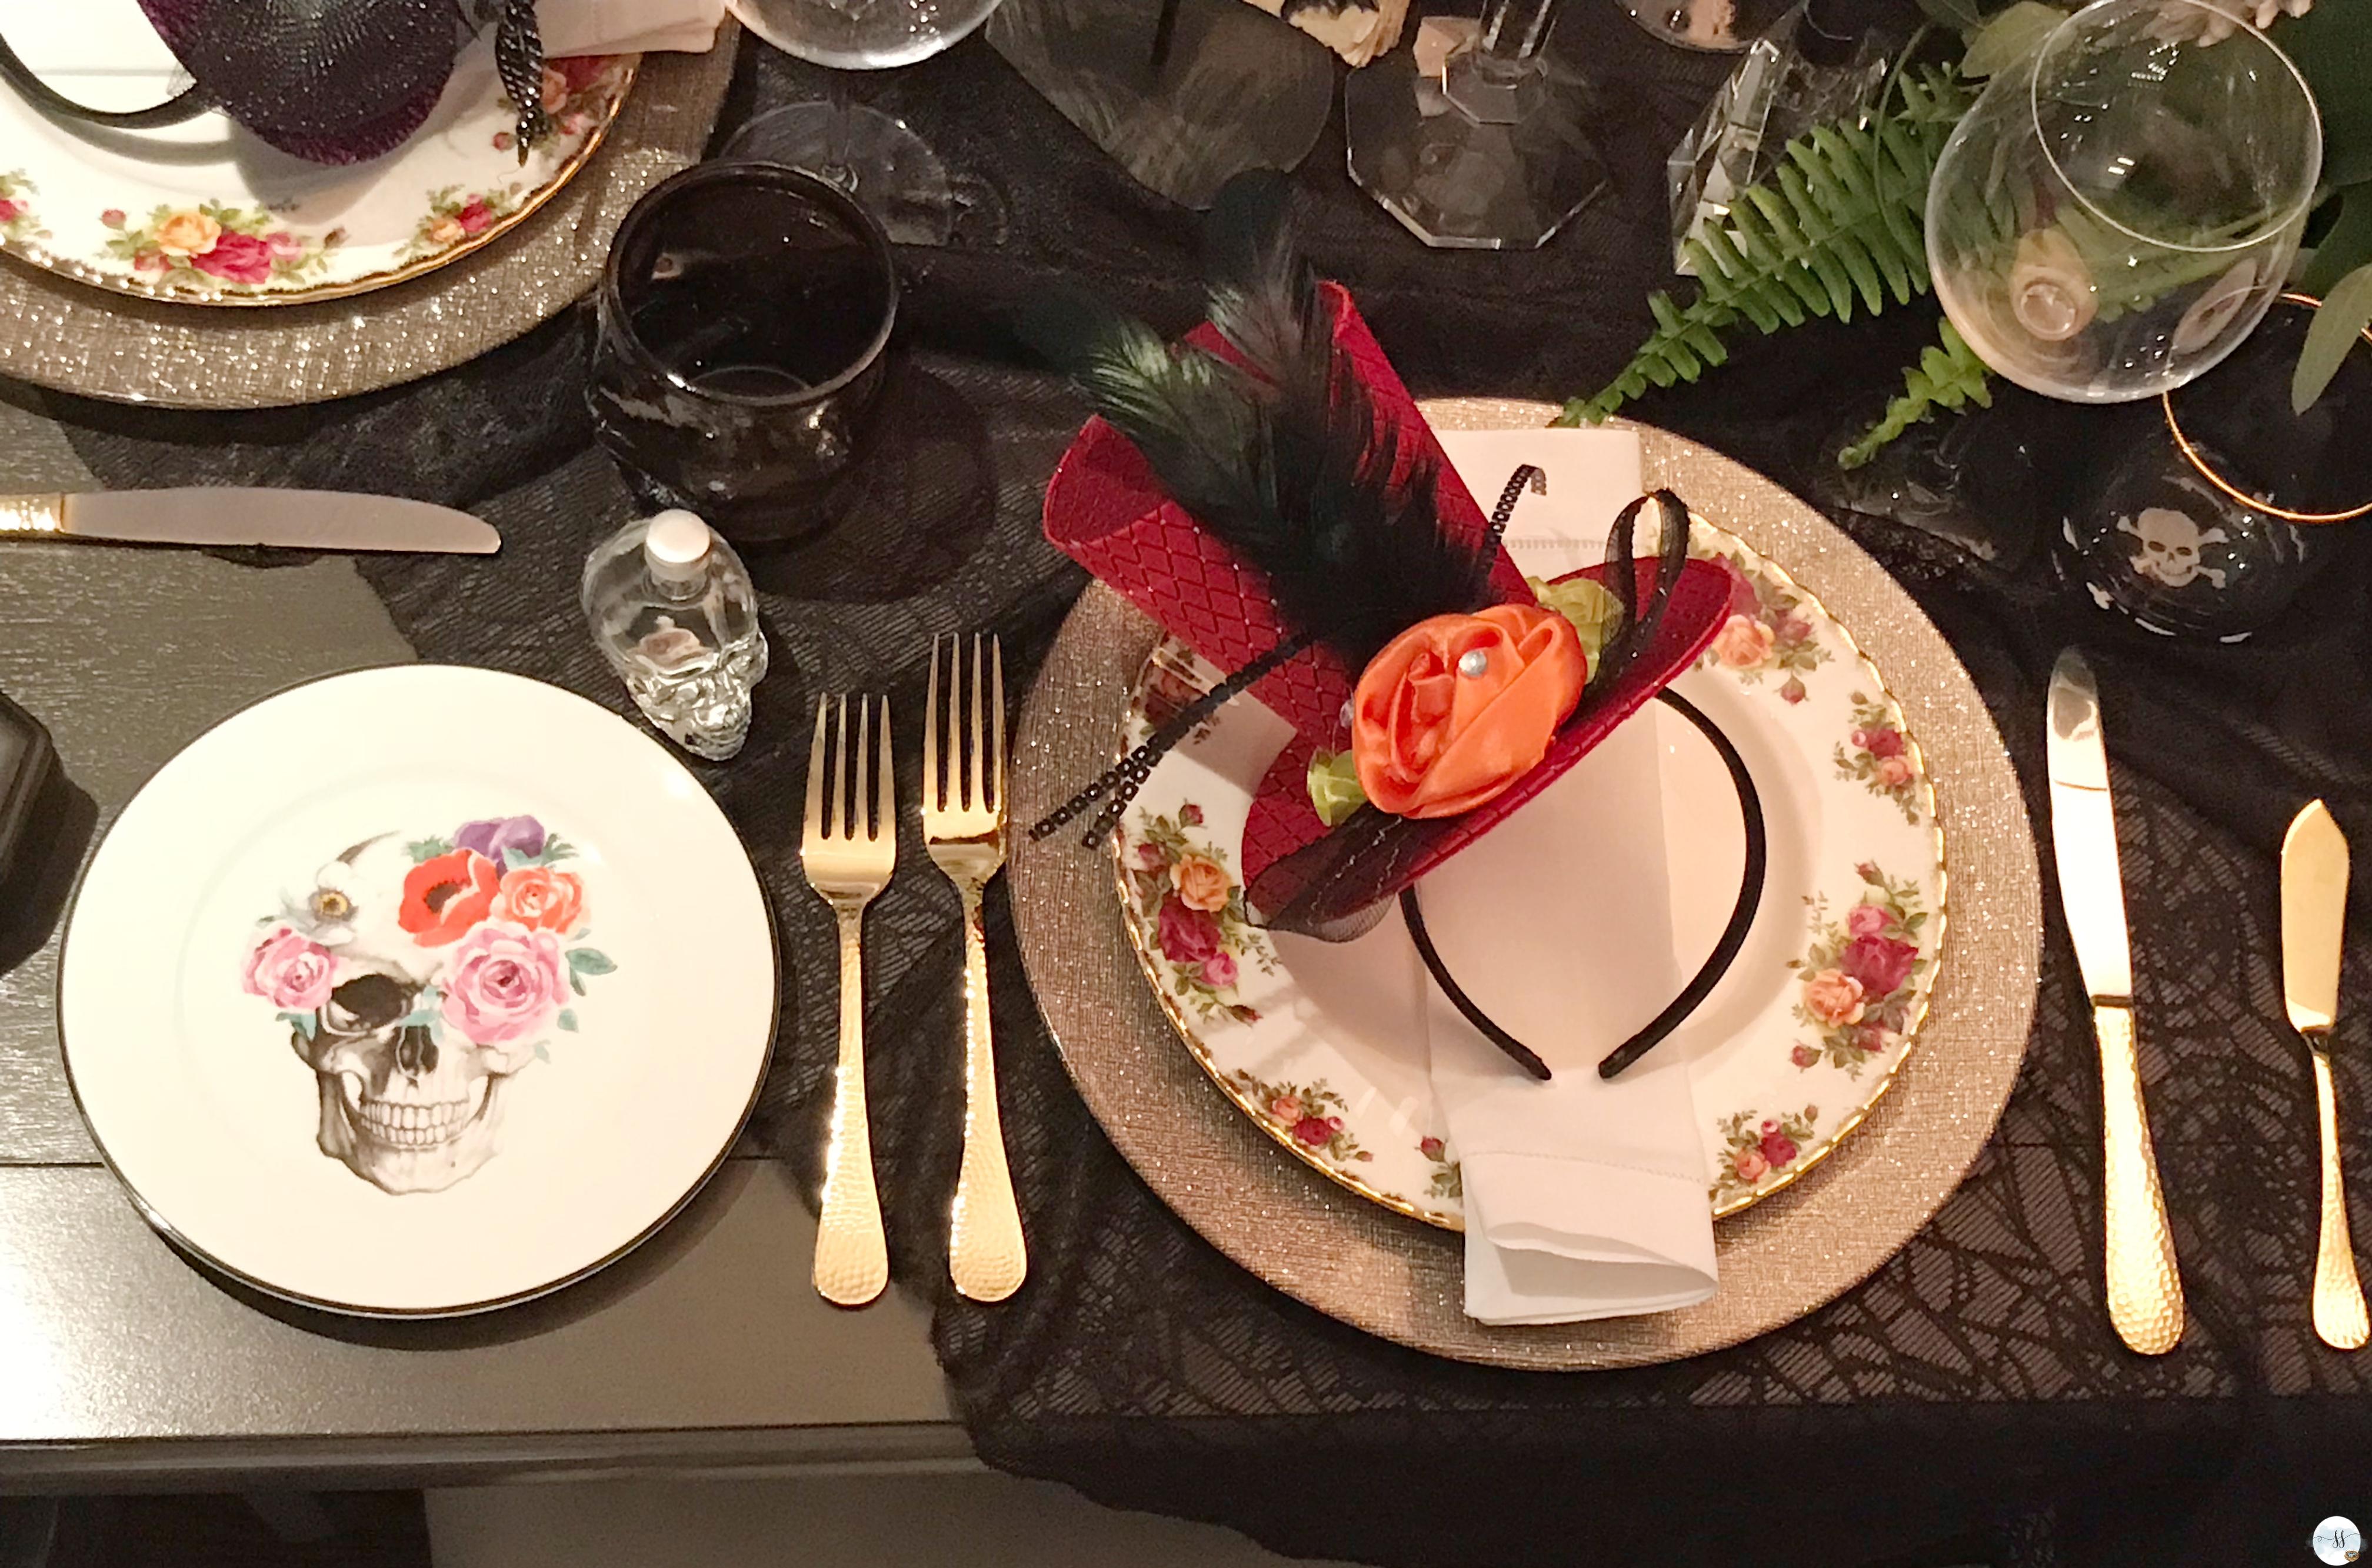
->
[922,633,1030,1302]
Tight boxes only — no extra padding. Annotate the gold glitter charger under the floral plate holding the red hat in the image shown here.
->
[1013,399,2040,1369]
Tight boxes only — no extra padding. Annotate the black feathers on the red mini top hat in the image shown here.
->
[1022,178,1482,671]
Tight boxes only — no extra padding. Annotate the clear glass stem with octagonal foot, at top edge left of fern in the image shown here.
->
[1342,0,1606,249]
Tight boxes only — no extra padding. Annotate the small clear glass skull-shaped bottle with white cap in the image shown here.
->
[581,510,766,762]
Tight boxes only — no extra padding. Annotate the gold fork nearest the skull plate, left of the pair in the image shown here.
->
[799,698,897,1307]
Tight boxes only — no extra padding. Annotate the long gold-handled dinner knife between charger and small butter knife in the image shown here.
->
[2047,648,2182,1355]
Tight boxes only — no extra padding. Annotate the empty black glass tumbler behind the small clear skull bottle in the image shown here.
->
[586,164,897,541]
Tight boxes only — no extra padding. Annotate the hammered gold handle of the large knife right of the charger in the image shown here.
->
[2092,1001,2182,1355]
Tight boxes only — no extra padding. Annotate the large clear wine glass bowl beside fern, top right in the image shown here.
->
[1926,0,2322,403]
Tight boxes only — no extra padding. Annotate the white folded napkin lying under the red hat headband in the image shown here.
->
[1421,429,1715,1324]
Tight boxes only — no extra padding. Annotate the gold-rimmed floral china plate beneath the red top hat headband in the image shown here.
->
[1115,519,1945,1229]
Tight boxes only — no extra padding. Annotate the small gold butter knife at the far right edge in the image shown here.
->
[2282,799,2372,1350]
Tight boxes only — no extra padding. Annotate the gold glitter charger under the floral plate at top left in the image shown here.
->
[0,24,738,408]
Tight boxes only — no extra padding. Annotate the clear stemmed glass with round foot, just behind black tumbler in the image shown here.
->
[726,0,996,244]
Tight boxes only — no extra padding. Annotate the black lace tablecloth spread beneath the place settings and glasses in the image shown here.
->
[9,12,2372,1568]
